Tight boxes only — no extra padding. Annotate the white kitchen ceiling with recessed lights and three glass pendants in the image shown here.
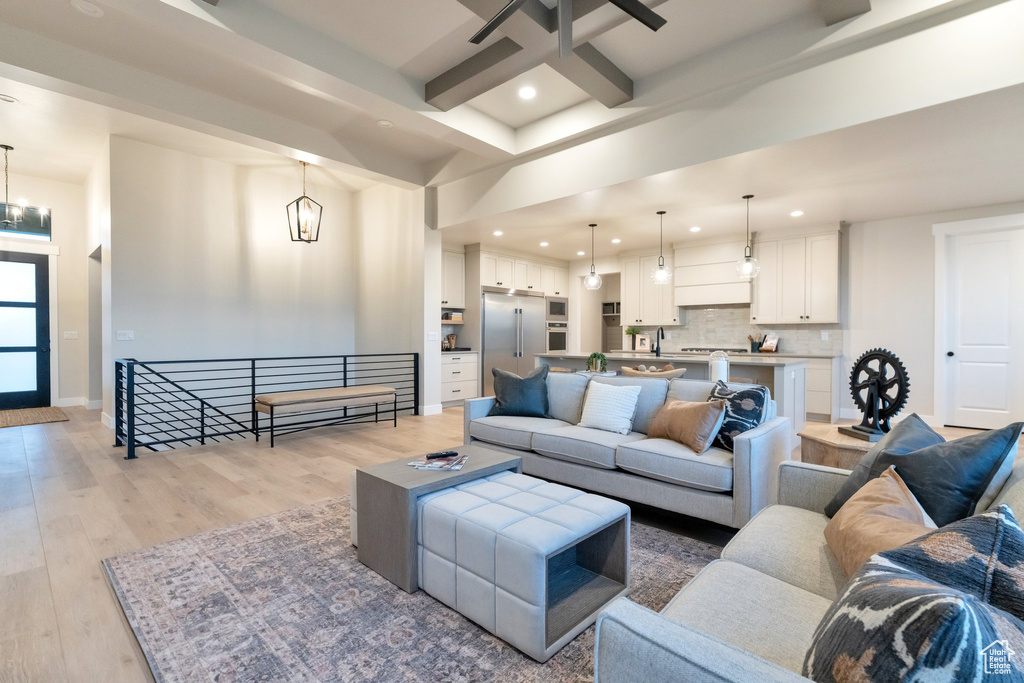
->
[442,86,1024,259]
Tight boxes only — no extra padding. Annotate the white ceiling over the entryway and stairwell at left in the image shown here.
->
[0,78,377,191]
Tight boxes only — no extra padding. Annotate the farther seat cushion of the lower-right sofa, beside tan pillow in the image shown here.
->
[722,505,847,600]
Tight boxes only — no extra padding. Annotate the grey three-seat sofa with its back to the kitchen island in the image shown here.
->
[465,373,792,528]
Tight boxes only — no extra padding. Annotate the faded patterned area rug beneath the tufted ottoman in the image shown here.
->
[103,498,721,683]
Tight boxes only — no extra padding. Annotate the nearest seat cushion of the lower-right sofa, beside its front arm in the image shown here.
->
[662,560,831,672]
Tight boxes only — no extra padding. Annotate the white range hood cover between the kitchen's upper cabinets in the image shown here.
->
[673,242,751,306]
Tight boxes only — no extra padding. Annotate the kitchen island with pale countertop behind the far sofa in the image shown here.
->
[537,351,807,438]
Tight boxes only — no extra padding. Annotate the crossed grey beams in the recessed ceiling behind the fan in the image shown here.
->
[425,0,666,112]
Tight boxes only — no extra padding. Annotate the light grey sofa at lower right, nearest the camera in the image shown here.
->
[595,461,1024,683]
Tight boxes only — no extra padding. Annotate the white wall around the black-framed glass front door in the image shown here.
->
[2,173,89,405]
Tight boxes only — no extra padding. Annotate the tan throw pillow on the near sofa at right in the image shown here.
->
[825,467,936,577]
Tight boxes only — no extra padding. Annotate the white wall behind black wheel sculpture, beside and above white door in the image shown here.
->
[841,198,1024,419]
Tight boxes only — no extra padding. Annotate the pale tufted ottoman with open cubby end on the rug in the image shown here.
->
[418,472,630,661]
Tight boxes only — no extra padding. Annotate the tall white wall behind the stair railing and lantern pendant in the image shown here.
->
[106,137,355,409]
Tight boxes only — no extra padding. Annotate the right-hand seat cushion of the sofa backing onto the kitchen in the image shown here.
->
[615,438,732,493]
